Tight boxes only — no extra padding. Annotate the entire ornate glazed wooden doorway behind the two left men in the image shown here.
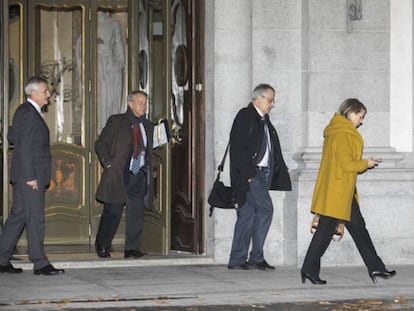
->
[1,0,205,254]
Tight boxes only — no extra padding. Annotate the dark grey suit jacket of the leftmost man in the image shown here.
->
[7,102,52,189]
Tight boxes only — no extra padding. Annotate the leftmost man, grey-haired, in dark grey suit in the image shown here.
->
[0,77,64,275]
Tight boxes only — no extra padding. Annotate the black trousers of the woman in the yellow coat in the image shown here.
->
[302,197,385,277]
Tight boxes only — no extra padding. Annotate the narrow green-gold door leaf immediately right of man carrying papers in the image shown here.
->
[134,0,170,254]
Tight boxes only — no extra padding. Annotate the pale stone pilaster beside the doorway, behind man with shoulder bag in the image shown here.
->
[210,0,252,263]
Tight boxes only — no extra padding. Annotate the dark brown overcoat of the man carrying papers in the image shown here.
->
[95,113,154,208]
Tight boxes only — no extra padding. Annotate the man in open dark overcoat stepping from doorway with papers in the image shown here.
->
[95,91,153,259]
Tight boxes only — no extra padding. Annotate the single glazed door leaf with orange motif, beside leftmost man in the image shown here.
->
[28,1,91,245]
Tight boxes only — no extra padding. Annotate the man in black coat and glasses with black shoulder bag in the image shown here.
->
[227,84,292,270]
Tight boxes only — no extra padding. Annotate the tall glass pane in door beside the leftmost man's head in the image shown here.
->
[35,6,85,146]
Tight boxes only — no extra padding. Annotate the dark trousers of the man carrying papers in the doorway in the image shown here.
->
[96,170,147,251]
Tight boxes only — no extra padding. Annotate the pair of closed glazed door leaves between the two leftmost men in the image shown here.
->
[28,0,129,247]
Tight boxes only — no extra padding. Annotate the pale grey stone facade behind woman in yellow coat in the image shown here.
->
[206,0,414,266]
